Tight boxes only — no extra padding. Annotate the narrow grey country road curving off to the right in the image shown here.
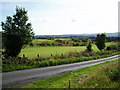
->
[2,55,119,88]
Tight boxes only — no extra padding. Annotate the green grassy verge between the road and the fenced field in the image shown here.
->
[2,52,120,72]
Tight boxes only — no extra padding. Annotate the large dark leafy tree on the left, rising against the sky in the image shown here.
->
[1,6,34,57]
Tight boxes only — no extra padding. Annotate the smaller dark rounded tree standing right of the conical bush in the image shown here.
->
[96,34,106,51]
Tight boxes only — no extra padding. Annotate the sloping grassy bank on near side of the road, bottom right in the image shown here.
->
[22,59,120,88]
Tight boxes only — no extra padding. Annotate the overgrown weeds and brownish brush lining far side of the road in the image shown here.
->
[2,51,120,72]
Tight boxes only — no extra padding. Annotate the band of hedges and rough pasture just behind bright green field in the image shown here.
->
[36,38,87,46]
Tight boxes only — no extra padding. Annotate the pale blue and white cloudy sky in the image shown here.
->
[0,0,119,35]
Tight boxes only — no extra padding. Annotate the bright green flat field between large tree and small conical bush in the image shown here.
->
[20,46,86,58]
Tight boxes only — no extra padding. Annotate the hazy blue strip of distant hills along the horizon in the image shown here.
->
[35,32,120,38]
